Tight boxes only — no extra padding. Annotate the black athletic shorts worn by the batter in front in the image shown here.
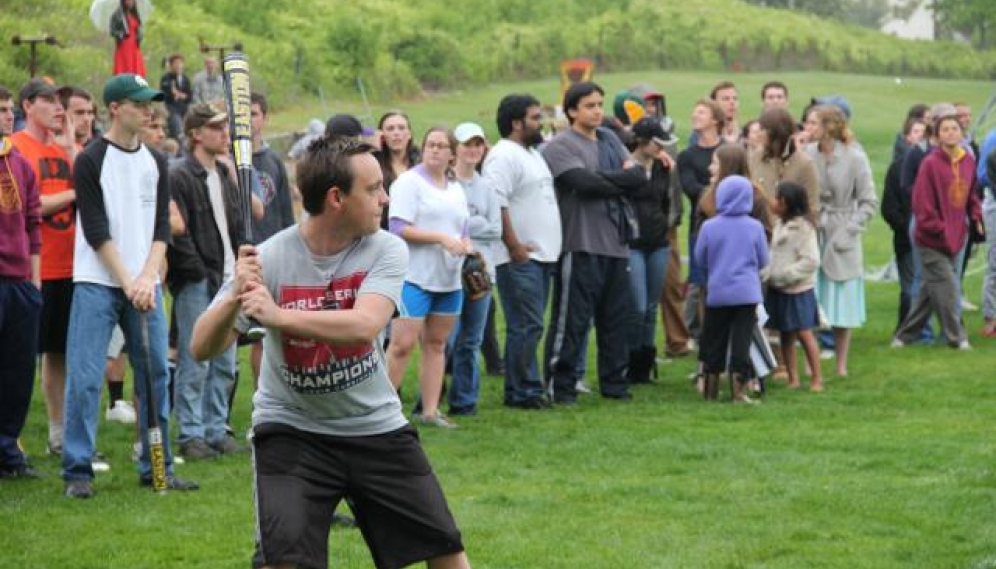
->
[252,423,463,569]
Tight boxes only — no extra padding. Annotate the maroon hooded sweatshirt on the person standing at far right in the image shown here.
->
[913,147,982,255]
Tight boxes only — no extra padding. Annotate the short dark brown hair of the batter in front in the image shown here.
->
[297,136,374,215]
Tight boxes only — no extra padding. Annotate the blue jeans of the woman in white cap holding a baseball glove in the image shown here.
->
[448,293,491,410]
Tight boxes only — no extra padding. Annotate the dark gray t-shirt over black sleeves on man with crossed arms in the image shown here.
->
[543,129,629,259]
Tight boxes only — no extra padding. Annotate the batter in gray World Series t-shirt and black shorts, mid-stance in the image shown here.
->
[191,137,470,569]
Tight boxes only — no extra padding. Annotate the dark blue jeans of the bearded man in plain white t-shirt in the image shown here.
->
[497,260,557,403]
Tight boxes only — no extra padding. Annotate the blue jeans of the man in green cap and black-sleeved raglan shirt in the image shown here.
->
[62,283,173,481]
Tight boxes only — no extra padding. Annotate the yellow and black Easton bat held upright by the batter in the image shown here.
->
[221,51,266,340]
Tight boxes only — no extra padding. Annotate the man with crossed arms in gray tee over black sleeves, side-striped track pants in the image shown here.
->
[543,83,646,405]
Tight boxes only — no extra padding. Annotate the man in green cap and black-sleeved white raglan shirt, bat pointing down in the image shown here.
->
[62,74,197,498]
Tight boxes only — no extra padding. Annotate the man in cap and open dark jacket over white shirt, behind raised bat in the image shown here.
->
[168,103,243,460]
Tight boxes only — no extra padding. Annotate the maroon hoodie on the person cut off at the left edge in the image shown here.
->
[0,138,41,280]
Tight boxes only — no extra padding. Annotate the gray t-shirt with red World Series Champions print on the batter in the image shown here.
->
[216,225,408,437]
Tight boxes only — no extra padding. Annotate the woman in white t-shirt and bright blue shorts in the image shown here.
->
[387,127,472,427]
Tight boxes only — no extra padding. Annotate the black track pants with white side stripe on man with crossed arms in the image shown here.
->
[544,253,633,401]
